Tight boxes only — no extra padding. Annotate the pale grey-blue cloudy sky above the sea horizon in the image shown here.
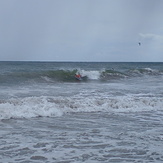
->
[0,0,163,62]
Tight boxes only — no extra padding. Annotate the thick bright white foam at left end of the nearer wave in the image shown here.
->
[0,97,62,119]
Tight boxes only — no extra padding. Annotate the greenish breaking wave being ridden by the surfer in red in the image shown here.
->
[0,68,163,83]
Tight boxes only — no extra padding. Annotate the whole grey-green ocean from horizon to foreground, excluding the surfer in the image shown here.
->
[0,62,163,163]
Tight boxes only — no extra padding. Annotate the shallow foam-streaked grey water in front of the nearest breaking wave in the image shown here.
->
[0,111,163,163]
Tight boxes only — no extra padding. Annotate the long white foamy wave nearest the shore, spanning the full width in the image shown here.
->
[0,96,163,120]
